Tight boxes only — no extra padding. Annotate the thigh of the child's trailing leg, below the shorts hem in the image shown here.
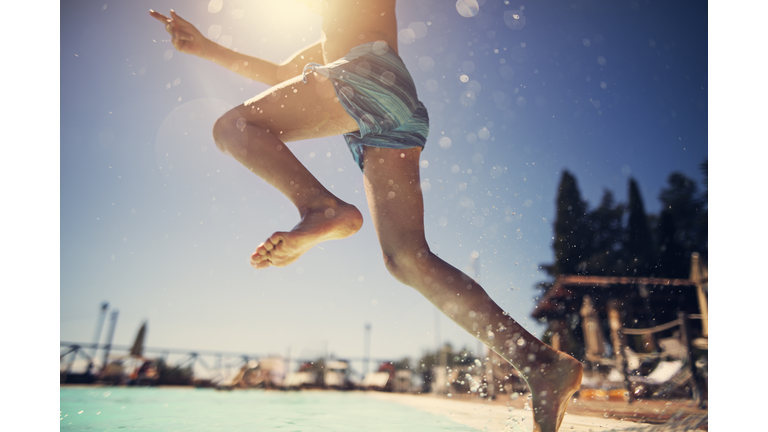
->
[363,147,427,255]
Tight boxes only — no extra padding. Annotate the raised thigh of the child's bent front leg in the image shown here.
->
[225,73,358,142]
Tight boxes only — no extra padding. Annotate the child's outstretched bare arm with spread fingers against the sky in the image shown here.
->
[149,9,325,85]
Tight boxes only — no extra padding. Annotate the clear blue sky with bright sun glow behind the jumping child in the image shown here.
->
[52,0,711,374]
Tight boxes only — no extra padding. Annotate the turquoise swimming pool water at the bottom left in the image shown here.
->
[59,387,477,432]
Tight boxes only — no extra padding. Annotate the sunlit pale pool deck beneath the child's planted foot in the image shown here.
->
[367,392,707,432]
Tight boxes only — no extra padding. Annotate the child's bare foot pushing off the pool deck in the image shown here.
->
[528,352,583,432]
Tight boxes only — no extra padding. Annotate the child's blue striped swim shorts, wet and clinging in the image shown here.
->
[303,42,429,170]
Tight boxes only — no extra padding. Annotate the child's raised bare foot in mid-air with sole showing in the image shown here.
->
[251,198,363,269]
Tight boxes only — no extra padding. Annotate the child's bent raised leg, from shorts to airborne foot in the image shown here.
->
[213,74,363,268]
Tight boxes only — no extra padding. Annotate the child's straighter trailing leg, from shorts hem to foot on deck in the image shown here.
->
[364,147,582,432]
